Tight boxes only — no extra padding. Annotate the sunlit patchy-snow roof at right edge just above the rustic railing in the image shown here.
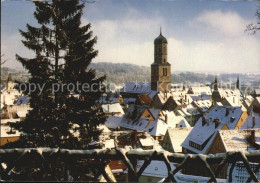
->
[219,129,260,151]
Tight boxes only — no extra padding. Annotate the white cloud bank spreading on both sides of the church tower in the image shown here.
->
[84,9,260,72]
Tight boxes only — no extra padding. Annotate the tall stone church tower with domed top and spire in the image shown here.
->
[151,30,171,92]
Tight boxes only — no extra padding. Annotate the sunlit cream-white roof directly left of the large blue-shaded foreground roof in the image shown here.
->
[167,127,192,152]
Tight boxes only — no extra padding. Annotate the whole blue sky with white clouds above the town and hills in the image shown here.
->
[1,0,260,73]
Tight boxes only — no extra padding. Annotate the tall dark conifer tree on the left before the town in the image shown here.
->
[8,0,105,149]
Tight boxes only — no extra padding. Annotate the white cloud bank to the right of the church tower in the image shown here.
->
[178,10,260,73]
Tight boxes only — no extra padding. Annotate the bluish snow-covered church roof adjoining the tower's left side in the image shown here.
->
[119,82,152,94]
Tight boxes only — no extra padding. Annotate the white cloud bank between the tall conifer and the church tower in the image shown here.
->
[82,8,164,66]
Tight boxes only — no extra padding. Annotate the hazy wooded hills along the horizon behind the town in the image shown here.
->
[1,62,260,88]
